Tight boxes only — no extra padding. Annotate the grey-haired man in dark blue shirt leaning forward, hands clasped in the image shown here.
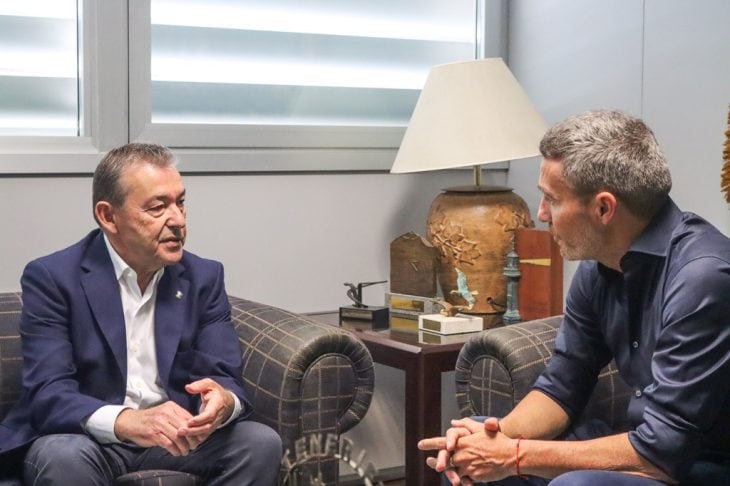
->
[419,111,730,486]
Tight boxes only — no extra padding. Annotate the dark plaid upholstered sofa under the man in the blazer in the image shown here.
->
[0,293,374,486]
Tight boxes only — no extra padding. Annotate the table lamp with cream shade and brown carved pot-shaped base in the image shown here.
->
[391,58,547,314]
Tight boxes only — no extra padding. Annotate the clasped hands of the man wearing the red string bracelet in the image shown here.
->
[418,417,516,486]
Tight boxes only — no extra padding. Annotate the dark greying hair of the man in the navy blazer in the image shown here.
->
[91,143,177,218]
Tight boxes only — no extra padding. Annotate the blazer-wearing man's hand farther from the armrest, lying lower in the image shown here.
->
[114,401,199,456]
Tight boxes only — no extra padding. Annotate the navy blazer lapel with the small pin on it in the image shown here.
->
[155,264,190,387]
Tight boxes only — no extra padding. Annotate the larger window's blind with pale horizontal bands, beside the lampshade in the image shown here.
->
[150,0,476,127]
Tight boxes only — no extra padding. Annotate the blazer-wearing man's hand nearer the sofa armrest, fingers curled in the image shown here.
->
[178,378,235,444]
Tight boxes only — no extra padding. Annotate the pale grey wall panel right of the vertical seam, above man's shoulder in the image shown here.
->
[643,0,730,234]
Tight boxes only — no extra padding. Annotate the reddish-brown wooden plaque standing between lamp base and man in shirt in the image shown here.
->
[515,228,563,321]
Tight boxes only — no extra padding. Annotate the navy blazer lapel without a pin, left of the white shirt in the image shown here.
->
[81,232,127,376]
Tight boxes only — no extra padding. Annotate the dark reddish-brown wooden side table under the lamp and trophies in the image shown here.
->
[308,312,502,486]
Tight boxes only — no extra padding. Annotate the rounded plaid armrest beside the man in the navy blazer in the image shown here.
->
[229,297,375,449]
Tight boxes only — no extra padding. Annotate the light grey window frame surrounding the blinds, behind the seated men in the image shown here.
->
[0,0,507,177]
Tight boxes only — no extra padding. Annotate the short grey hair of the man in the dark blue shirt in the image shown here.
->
[540,110,672,219]
